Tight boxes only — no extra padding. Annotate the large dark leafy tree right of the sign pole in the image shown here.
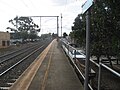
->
[91,0,120,65]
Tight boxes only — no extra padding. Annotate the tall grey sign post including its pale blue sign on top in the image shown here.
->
[82,0,93,90]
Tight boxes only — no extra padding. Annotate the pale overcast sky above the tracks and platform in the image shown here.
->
[0,0,86,36]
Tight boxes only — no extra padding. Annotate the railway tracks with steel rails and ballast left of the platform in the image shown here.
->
[0,41,51,90]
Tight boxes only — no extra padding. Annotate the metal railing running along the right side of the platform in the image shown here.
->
[62,41,120,90]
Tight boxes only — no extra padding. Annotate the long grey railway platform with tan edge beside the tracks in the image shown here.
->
[10,39,83,90]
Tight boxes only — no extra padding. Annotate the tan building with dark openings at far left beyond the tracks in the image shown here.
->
[0,32,10,48]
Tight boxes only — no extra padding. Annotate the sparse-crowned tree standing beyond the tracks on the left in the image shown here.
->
[8,16,40,39]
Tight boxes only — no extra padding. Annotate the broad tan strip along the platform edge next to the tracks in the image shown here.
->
[9,40,54,90]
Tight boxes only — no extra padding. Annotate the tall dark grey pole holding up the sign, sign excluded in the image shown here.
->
[84,10,90,90]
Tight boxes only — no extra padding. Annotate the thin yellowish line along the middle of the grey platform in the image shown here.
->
[40,41,54,90]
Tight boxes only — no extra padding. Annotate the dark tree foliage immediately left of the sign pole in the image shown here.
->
[71,14,86,48]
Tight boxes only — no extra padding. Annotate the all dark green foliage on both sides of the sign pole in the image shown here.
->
[70,0,120,61]
